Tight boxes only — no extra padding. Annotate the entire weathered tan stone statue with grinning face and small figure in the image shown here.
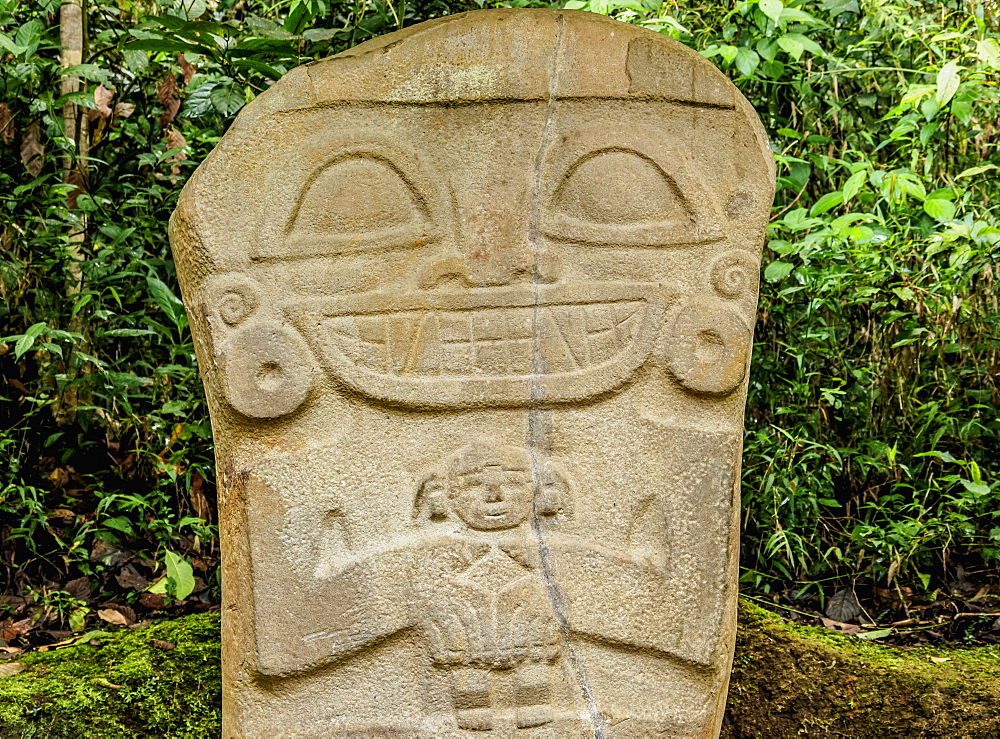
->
[171,10,773,737]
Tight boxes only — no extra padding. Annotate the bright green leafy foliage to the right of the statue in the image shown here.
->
[622,0,1000,590]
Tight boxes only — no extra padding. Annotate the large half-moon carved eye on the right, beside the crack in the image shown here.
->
[545,147,723,246]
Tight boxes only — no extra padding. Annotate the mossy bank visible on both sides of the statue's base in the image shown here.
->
[0,604,1000,739]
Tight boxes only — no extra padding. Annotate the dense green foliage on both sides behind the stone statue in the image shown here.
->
[0,0,1000,612]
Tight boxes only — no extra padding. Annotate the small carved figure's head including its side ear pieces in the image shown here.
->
[417,444,568,531]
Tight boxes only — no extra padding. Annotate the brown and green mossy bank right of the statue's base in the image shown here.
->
[722,603,1000,739]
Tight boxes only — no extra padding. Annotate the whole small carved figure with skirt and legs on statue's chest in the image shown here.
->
[417,445,567,730]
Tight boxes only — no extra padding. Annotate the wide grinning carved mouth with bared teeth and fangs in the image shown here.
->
[284,283,663,407]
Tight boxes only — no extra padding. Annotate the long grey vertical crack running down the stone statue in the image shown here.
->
[527,14,607,739]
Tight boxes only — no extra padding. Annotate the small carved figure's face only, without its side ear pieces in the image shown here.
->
[449,465,535,531]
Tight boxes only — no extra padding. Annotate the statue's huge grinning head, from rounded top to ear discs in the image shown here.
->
[174,10,773,418]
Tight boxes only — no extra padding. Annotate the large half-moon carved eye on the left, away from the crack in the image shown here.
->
[287,154,429,256]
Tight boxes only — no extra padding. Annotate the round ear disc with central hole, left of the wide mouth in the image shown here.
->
[222,323,312,418]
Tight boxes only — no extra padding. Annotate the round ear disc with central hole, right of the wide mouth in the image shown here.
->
[666,299,753,397]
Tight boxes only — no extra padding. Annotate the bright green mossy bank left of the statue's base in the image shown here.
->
[0,614,222,739]
